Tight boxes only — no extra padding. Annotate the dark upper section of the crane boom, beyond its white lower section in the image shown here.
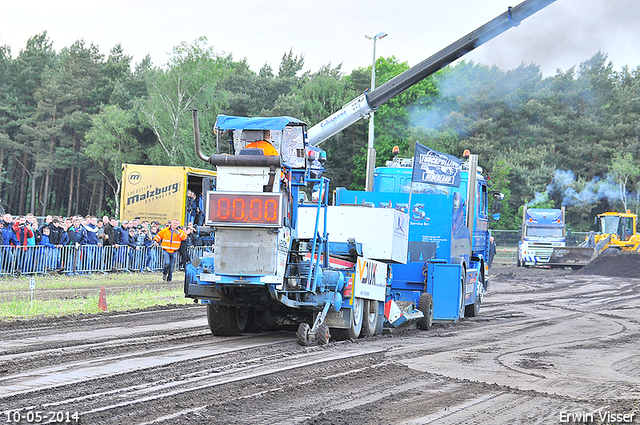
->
[367,0,556,109]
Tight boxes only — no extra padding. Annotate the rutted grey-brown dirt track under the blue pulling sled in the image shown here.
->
[0,268,640,424]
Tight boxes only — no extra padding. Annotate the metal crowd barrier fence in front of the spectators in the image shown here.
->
[0,245,213,276]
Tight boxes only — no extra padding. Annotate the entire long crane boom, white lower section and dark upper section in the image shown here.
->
[308,0,556,146]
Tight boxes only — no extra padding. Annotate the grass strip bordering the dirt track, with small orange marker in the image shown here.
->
[0,288,193,320]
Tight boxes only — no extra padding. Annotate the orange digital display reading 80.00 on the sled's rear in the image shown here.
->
[206,191,282,227]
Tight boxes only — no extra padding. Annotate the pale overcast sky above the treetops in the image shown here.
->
[0,0,640,76]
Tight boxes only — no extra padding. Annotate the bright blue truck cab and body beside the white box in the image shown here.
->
[334,152,500,322]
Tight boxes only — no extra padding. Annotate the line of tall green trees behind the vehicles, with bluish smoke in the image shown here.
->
[0,32,640,230]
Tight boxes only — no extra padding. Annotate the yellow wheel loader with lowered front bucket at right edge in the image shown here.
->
[549,211,640,269]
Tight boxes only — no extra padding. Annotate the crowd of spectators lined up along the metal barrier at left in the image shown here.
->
[0,214,201,274]
